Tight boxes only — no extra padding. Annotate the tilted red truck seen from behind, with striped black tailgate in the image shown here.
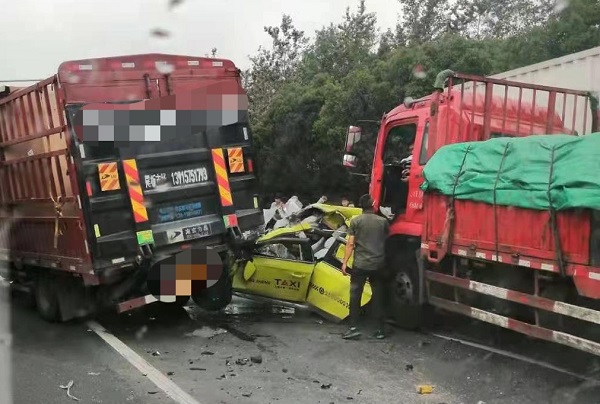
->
[0,54,263,321]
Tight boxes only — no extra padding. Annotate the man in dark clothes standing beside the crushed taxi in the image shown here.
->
[342,194,389,339]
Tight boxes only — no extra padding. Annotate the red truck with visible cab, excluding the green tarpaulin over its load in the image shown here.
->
[344,48,600,355]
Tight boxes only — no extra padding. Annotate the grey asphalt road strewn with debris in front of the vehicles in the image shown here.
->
[7,294,600,404]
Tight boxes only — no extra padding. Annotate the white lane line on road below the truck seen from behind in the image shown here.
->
[87,321,200,404]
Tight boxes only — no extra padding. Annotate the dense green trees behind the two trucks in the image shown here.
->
[245,0,600,201]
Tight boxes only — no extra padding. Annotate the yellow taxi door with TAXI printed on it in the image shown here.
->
[233,237,315,303]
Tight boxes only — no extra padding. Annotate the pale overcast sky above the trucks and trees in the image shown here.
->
[0,0,400,84]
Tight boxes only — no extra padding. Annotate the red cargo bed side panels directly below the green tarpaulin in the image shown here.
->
[423,193,590,265]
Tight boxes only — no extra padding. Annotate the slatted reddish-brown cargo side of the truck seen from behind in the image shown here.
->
[0,77,91,274]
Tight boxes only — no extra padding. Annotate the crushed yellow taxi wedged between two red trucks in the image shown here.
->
[232,204,371,320]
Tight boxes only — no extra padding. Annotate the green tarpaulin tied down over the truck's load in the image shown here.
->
[421,133,600,210]
